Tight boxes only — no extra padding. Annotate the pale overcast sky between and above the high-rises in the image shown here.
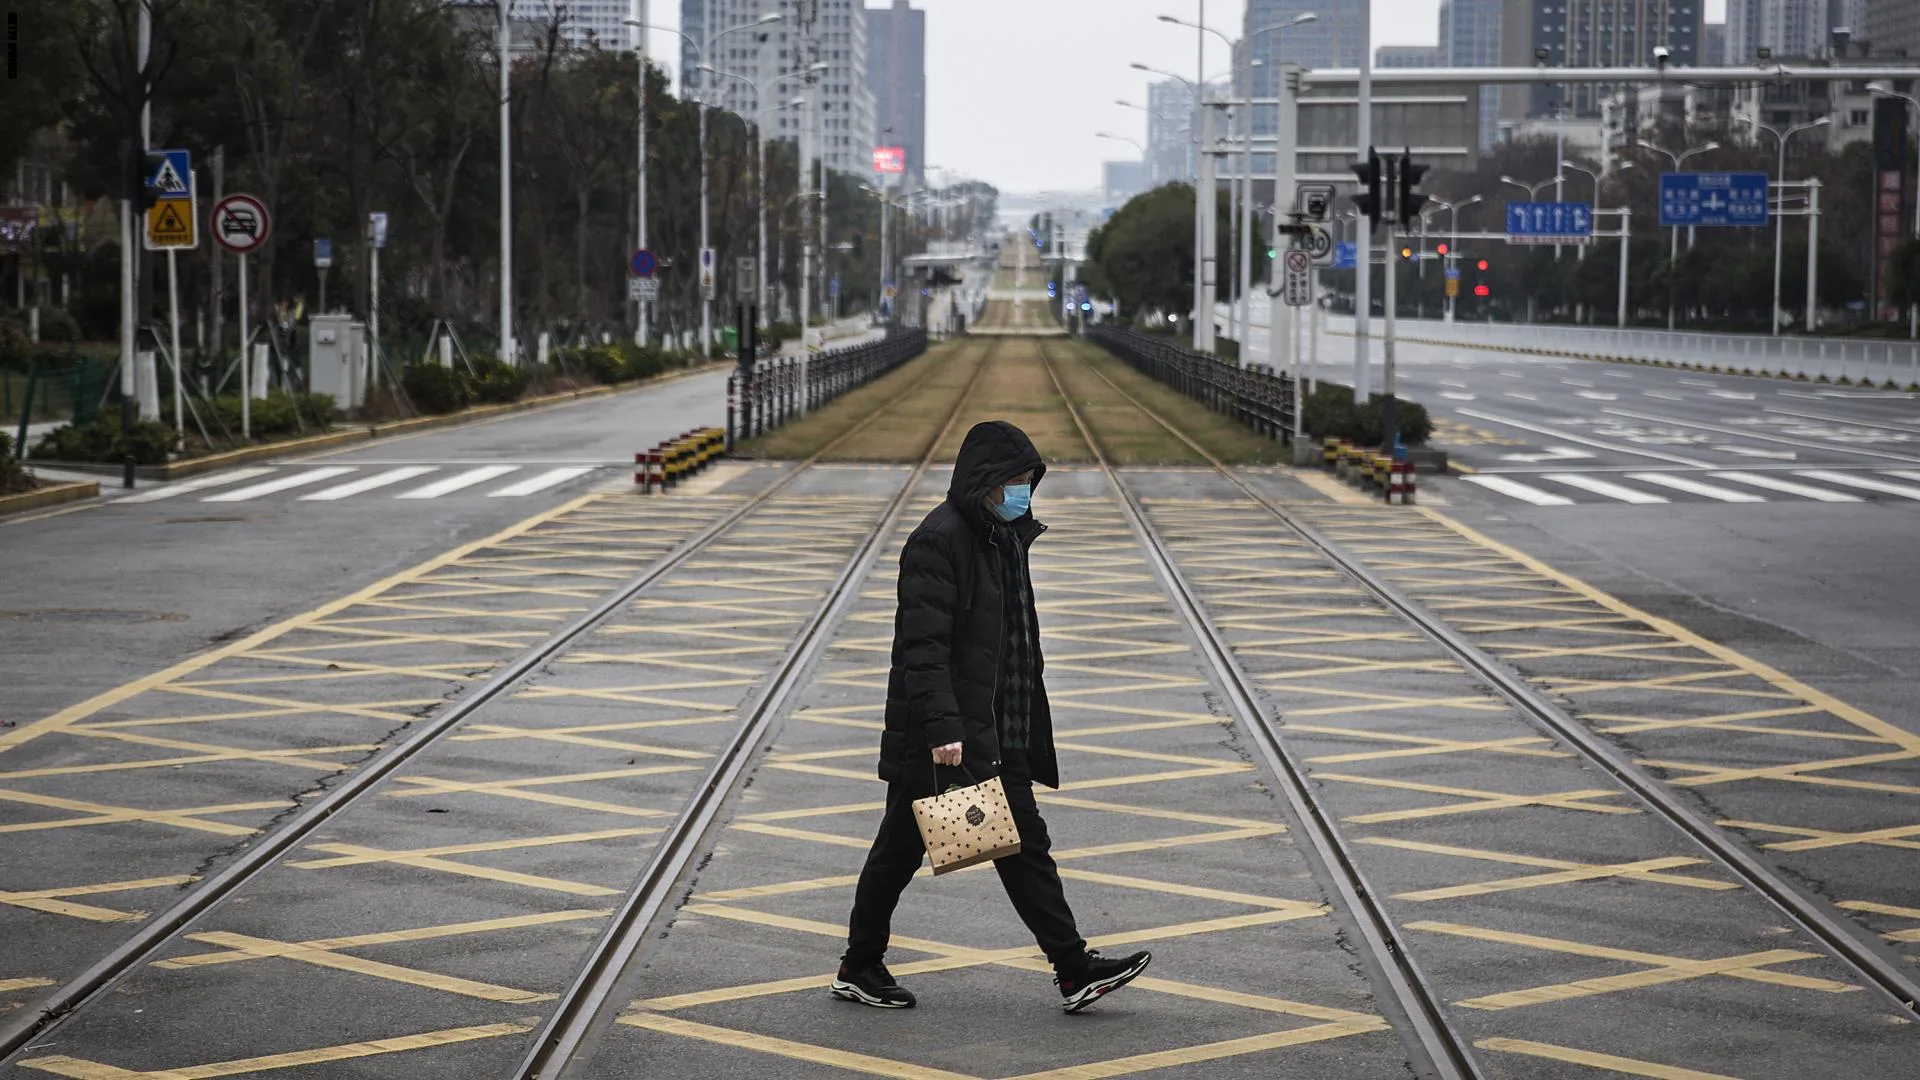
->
[649,0,1724,194]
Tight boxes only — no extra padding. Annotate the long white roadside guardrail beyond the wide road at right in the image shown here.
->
[1327,315,1920,386]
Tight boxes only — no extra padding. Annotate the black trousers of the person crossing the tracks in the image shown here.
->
[843,761,1087,972]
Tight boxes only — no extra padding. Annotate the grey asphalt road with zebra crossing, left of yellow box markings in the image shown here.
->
[0,365,726,732]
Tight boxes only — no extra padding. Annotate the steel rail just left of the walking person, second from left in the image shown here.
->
[515,338,995,1080]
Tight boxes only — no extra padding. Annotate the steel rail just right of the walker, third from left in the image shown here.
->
[1041,338,1482,1080]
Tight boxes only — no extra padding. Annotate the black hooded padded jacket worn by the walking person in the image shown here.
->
[879,421,1060,794]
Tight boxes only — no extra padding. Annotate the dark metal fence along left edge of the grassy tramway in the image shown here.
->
[726,329,927,450]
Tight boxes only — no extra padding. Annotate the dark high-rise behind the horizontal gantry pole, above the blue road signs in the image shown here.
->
[1500,0,1712,121]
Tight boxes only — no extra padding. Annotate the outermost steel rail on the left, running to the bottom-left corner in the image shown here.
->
[0,336,991,1065]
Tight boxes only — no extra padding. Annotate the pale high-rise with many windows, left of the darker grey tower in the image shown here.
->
[680,0,874,177]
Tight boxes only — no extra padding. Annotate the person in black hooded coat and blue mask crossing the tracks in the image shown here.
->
[833,421,1152,1013]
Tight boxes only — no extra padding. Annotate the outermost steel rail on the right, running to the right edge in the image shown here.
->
[1059,338,1920,1015]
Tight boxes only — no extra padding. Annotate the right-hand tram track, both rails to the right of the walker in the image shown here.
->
[1043,336,1920,1045]
